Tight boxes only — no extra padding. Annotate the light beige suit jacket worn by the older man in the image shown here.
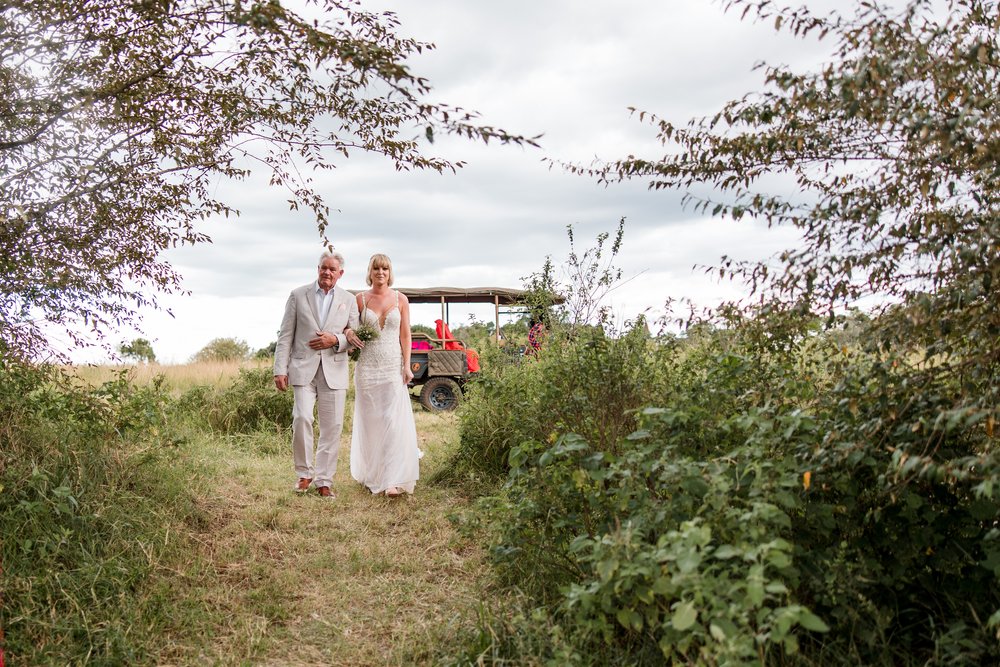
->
[274,282,358,389]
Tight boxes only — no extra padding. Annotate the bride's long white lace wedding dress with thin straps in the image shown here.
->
[351,293,421,493]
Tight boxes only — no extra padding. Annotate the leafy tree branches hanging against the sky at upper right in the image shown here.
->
[573,0,1000,316]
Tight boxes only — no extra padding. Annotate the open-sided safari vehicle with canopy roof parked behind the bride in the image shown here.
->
[399,287,548,412]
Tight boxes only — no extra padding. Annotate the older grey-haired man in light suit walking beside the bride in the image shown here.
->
[274,252,361,498]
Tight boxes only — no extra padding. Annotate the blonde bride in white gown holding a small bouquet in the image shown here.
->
[351,254,421,497]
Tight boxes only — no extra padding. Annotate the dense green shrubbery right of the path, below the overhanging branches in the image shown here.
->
[462,315,1000,665]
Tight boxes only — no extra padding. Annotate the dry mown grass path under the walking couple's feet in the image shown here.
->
[157,412,484,665]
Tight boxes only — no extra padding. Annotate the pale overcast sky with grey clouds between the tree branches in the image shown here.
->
[70,0,844,363]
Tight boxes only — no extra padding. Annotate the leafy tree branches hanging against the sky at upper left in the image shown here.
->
[0,0,533,356]
